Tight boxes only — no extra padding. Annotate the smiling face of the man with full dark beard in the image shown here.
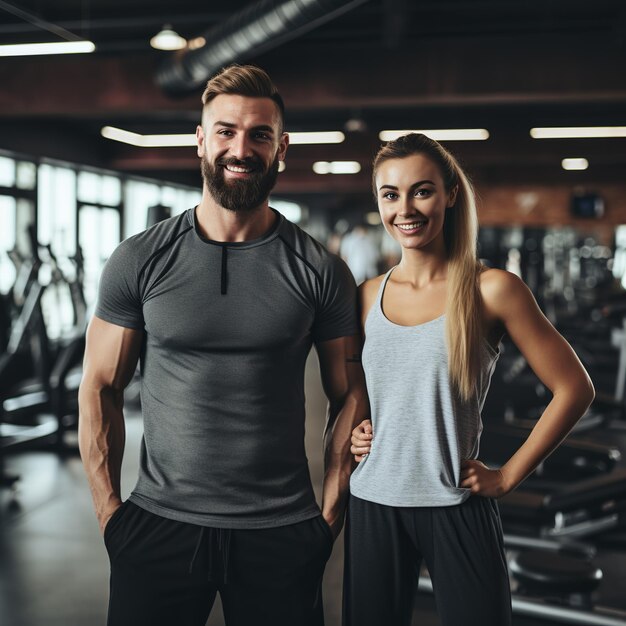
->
[196,94,289,212]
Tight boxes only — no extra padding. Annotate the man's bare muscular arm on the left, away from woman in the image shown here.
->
[78,317,142,532]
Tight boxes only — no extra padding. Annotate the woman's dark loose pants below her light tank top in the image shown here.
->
[344,496,511,626]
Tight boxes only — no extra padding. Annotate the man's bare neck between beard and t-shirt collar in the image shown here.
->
[196,189,276,243]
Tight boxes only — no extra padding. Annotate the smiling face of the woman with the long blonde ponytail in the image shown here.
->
[376,154,457,248]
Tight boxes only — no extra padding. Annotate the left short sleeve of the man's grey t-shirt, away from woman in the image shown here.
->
[95,238,144,329]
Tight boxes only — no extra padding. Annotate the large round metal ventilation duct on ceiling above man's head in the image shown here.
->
[157,0,367,94]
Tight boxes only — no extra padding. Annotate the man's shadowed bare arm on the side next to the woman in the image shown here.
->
[316,335,369,536]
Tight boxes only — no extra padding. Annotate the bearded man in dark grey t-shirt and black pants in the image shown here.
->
[80,66,365,626]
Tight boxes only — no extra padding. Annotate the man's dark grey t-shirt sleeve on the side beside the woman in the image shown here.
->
[312,254,359,343]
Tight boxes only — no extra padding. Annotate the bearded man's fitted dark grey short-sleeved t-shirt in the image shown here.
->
[95,209,358,528]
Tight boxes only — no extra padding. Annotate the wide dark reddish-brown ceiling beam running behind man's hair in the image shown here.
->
[0,31,626,119]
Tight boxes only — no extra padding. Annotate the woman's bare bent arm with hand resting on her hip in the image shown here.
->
[461,270,595,497]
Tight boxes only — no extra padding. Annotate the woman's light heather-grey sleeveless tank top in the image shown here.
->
[350,268,499,507]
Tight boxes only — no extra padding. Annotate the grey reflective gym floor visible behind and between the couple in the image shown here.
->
[0,356,626,626]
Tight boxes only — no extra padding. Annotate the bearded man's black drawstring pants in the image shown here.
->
[104,501,333,626]
